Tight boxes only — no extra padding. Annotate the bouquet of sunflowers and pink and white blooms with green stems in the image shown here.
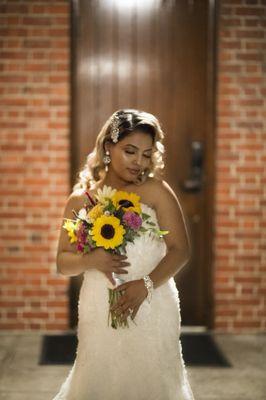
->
[63,185,169,329]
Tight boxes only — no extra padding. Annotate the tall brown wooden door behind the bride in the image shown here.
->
[71,0,215,328]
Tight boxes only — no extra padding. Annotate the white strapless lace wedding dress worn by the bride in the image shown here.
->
[53,203,194,400]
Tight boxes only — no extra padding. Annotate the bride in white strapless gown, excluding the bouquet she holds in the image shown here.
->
[54,109,194,400]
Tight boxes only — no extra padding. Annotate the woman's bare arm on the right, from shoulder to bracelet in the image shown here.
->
[149,181,192,288]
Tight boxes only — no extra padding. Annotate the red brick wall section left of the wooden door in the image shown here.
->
[0,0,69,330]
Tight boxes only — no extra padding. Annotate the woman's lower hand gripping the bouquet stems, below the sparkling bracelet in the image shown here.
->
[111,279,148,321]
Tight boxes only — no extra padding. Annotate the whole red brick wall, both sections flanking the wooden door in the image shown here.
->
[0,0,266,332]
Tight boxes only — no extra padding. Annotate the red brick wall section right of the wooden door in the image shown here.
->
[214,0,266,332]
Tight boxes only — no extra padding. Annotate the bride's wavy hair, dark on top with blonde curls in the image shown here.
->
[73,109,164,191]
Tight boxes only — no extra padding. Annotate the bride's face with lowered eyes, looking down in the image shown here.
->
[106,131,153,182]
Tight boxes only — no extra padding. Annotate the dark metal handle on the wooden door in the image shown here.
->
[181,140,203,193]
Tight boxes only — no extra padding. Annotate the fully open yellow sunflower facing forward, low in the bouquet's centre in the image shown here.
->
[91,215,126,249]
